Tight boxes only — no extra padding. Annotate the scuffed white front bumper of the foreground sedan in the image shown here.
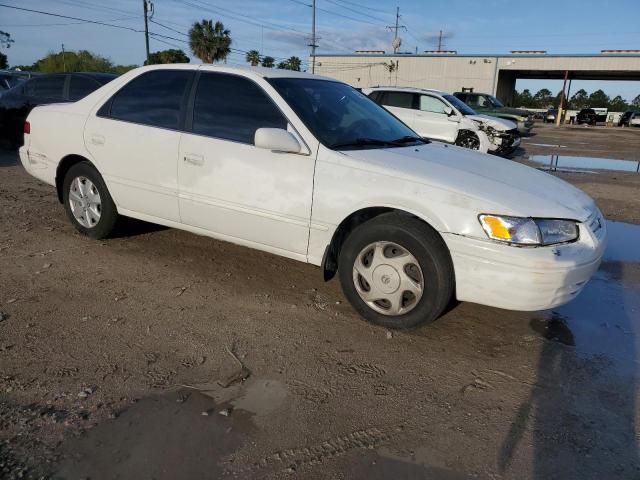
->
[443,212,606,311]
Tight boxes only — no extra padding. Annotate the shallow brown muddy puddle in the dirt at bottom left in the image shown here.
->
[56,390,255,480]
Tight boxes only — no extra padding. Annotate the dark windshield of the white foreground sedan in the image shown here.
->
[269,78,425,150]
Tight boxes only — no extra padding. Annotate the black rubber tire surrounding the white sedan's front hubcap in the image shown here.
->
[338,213,454,329]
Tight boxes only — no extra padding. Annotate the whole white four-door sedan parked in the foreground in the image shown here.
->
[20,64,606,328]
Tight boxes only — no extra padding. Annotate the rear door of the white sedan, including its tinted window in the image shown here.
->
[84,69,195,222]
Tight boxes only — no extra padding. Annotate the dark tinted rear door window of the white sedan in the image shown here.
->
[105,70,193,130]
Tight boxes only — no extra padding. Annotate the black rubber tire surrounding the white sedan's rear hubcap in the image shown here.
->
[62,162,118,240]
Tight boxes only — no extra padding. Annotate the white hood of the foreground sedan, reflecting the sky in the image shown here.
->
[342,142,595,221]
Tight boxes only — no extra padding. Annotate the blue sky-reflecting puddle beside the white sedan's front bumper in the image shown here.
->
[529,221,640,376]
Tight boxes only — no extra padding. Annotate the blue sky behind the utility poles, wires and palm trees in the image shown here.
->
[0,0,640,99]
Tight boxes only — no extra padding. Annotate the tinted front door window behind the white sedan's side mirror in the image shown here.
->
[193,72,287,145]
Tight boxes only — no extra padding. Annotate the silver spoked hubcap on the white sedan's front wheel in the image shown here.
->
[353,242,424,316]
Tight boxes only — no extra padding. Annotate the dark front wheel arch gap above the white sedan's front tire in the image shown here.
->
[321,206,448,281]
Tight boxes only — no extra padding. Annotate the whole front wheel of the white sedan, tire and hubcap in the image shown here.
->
[338,213,454,329]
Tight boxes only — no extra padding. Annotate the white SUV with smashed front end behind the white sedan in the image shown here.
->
[362,87,520,155]
